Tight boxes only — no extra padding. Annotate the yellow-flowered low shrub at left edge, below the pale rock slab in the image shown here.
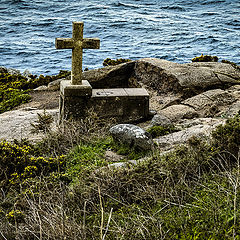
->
[0,141,65,188]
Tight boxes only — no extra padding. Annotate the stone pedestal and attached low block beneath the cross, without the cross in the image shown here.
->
[59,80,149,122]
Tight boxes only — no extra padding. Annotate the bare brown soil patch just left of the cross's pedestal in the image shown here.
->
[15,91,59,109]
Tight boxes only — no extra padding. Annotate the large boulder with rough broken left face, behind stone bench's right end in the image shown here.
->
[135,58,240,92]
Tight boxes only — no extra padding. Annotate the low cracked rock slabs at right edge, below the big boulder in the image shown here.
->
[158,85,240,122]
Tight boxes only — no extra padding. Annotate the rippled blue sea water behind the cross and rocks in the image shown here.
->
[0,0,240,74]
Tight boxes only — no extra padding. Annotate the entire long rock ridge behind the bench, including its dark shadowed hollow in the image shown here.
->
[32,58,240,95]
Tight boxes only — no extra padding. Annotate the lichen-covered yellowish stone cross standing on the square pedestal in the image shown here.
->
[55,22,100,85]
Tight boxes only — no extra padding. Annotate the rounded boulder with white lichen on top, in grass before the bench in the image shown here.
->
[109,124,153,150]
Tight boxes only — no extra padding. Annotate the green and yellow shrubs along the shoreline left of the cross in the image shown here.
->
[0,70,70,113]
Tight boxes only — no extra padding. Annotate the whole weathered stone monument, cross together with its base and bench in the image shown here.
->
[55,22,149,122]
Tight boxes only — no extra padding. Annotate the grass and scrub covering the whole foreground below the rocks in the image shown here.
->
[0,111,240,240]
